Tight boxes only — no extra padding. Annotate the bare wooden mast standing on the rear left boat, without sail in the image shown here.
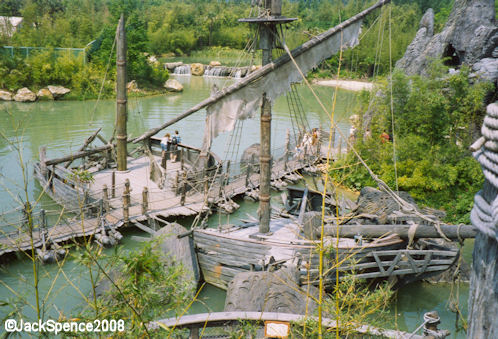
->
[116,14,128,171]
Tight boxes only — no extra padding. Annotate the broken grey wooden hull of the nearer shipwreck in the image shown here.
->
[193,219,459,289]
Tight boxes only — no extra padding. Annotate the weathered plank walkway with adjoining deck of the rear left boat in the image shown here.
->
[0,141,322,256]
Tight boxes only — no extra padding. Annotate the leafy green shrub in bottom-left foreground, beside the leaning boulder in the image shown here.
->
[79,241,194,337]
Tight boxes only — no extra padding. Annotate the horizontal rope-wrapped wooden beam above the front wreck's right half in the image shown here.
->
[316,225,477,240]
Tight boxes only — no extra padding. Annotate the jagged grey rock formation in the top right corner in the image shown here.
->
[396,0,498,81]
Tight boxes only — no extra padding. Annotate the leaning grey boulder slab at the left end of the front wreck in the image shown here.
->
[154,223,200,286]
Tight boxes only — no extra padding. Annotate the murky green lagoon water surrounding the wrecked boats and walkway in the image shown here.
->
[0,76,469,337]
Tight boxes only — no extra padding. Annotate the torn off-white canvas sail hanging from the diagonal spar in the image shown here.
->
[202,20,361,150]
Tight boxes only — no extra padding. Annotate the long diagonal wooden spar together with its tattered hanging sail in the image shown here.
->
[134,0,390,147]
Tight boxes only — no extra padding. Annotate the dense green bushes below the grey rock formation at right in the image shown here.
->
[331,63,492,223]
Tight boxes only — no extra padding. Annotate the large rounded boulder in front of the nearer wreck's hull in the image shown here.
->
[225,265,318,314]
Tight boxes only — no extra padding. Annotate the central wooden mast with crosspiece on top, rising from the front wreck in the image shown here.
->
[240,0,295,233]
